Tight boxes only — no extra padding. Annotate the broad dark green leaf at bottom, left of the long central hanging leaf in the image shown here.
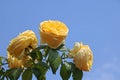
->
[32,62,48,80]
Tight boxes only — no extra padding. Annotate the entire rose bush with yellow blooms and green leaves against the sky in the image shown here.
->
[0,20,93,80]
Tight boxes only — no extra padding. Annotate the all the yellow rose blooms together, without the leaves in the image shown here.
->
[7,20,93,71]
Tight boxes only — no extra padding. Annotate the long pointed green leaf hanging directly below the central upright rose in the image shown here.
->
[48,49,62,74]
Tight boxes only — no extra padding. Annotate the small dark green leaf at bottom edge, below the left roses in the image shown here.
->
[22,68,32,80]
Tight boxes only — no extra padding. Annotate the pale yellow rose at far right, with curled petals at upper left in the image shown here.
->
[69,42,93,71]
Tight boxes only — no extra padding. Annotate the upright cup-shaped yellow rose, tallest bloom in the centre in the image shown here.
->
[39,20,69,49]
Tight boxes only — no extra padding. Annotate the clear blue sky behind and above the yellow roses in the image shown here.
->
[0,0,120,80]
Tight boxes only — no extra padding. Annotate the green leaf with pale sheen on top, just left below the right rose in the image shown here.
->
[60,62,72,80]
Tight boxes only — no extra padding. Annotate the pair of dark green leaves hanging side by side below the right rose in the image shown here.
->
[60,62,83,80]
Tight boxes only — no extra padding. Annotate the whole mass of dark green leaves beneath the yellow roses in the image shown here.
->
[0,44,83,80]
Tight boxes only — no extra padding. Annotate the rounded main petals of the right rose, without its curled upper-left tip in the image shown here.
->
[74,45,93,71]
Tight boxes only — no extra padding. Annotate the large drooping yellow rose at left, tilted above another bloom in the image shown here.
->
[7,30,38,58]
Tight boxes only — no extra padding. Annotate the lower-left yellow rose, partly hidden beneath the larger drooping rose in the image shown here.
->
[7,53,31,68]
